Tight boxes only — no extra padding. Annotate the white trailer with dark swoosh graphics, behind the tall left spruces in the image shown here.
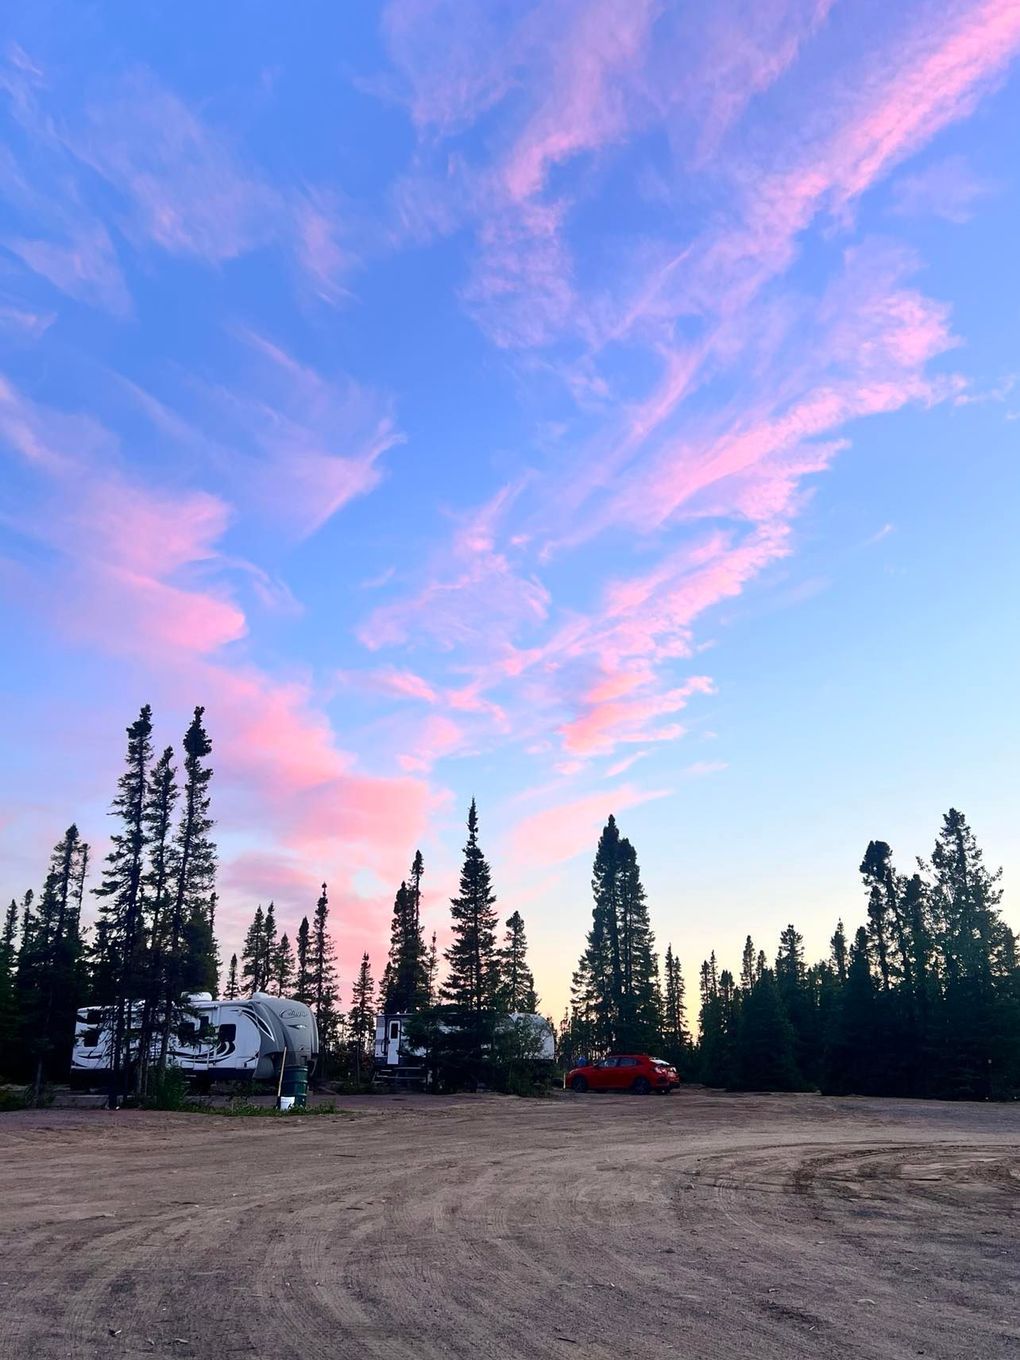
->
[71,991,318,1081]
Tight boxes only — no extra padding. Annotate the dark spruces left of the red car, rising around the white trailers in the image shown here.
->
[0,704,537,1099]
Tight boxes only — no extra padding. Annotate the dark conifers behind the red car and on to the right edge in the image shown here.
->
[560,809,1020,1099]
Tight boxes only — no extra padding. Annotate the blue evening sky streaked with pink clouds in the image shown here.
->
[0,0,1020,1015]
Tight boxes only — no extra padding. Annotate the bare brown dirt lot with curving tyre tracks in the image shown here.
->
[0,1088,1020,1360]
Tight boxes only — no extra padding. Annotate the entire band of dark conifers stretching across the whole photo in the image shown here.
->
[0,706,1020,1099]
